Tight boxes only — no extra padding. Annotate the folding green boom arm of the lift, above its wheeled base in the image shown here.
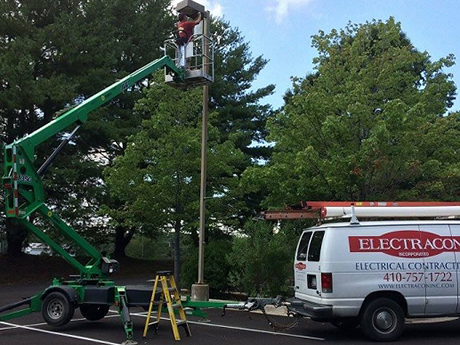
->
[2,56,184,279]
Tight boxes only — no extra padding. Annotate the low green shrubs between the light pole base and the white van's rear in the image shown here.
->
[181,221,305,297]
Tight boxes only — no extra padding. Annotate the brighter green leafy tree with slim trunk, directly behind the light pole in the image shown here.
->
[106,75,242,280]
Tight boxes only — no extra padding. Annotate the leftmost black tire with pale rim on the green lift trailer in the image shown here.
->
[42,291,75,327]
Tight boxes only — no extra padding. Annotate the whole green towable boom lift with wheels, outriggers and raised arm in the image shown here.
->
[0,29,216,343]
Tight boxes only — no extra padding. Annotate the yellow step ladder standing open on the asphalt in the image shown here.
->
[143,271,192,340]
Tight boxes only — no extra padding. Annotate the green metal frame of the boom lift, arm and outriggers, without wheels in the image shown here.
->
[0,45,229,340]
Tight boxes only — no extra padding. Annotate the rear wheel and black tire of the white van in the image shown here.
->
[360,298,405,341]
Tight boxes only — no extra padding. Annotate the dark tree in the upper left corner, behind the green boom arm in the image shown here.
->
[0,0,85,255]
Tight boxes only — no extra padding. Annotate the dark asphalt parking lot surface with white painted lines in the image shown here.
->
[0,285,460,345]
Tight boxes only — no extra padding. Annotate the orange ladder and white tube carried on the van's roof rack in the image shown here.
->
[263,201,460,220]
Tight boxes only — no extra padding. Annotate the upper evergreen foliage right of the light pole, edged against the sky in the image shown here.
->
[210,20,275,155]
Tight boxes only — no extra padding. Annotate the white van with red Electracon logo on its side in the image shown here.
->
[290,220,460,341]
